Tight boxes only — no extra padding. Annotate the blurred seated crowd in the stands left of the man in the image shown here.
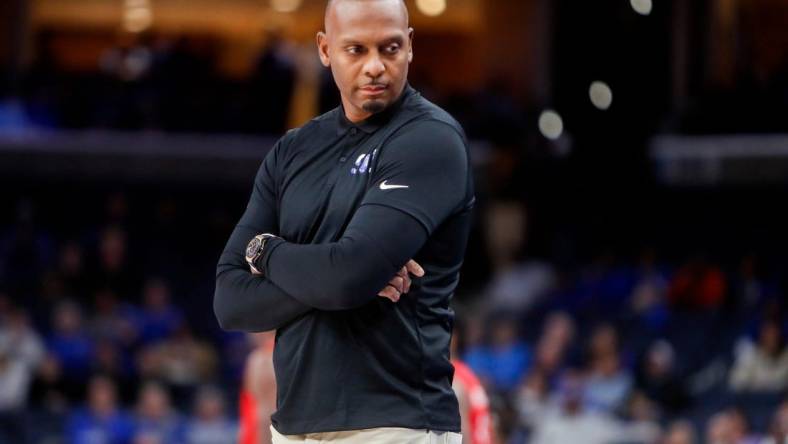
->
[0,196,245,444]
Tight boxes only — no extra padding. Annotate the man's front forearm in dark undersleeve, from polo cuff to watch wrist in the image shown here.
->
[263,205,427,310]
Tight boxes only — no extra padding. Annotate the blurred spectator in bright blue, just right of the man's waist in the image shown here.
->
[465,315,531,392]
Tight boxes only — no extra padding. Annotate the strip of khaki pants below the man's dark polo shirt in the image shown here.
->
[271,426,462,444]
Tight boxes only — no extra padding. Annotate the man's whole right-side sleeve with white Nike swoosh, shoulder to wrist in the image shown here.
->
[262,121,469,310]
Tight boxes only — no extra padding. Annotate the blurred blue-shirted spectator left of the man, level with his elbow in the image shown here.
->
[137,279,184,344]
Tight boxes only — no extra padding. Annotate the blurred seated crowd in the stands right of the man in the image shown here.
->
[458,203,788,444]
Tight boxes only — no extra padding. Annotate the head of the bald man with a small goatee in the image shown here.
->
[317,0,413,122]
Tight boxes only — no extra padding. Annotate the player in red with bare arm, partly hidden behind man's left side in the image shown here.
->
[239,331,276,444]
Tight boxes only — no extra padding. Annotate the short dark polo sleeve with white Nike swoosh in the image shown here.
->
[361,120,469,234]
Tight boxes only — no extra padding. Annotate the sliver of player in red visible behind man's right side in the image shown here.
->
[451,319,494,444]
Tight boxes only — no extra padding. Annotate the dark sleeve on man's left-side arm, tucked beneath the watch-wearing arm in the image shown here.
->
[213,141,312,331]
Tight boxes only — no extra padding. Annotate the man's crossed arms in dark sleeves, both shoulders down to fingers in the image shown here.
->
[214,122,468,331]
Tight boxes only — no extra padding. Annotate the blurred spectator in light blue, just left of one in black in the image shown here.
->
[584,325,633,412]
